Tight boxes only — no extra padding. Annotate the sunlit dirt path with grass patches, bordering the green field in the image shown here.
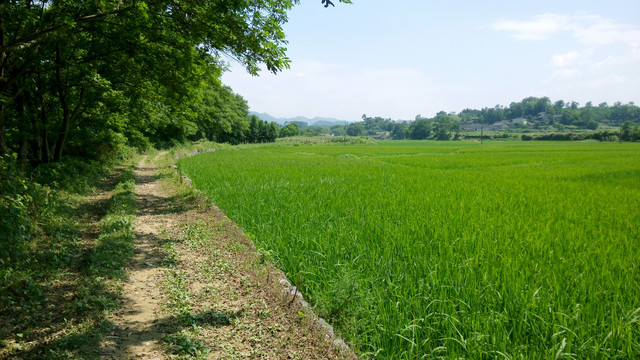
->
[102,154,355,359]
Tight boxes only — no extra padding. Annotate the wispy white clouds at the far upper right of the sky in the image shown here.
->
[493,13,640,92]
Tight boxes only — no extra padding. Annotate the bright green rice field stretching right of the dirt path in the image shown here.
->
[179,141,640,359]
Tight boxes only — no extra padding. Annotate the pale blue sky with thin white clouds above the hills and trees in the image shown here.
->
[222,0,640,121]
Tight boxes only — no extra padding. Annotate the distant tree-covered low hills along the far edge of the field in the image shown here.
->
[312,97,640,141]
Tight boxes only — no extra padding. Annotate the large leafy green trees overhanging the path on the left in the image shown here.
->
[0,0,295,168]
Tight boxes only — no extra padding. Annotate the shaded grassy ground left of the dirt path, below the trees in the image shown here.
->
[0,162,136,359]
